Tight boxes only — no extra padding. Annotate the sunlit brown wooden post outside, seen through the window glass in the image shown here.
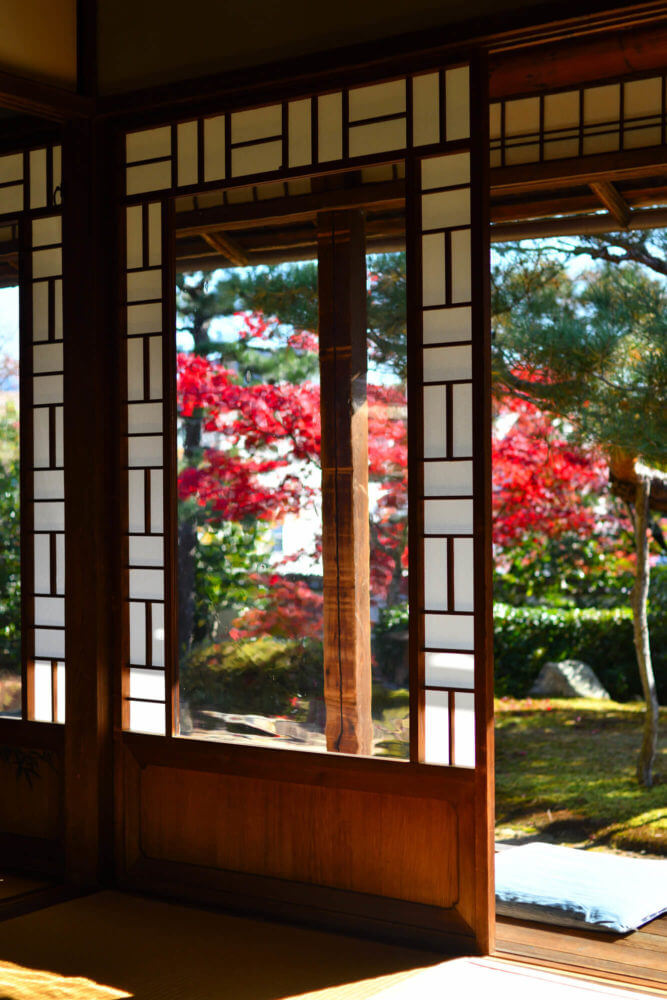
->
[318,211,373,754]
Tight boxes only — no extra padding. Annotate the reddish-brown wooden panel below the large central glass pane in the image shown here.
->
[136,765,460,907]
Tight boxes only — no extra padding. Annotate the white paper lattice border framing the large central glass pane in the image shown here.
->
[123,63,489,768]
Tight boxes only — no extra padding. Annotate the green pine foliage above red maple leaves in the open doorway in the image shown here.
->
[492,245,667,467]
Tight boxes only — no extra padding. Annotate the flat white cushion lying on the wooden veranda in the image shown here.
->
[496,844,667,934]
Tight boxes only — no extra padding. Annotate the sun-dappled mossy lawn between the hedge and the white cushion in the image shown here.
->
[496,698,667,856]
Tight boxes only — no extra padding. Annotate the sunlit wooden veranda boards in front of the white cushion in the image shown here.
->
[496,916,667,990]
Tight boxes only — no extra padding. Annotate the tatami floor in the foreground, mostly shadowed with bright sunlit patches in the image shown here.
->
[0,892,660,1000]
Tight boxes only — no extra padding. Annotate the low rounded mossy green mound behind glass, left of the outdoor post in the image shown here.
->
[181,638,324,718]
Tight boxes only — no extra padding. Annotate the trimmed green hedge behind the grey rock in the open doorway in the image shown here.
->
[493,604,667,704]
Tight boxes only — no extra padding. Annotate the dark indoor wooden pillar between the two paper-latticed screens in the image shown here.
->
[63,121,118,887]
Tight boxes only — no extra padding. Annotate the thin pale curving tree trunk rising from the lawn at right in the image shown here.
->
[632,476,658,788]
